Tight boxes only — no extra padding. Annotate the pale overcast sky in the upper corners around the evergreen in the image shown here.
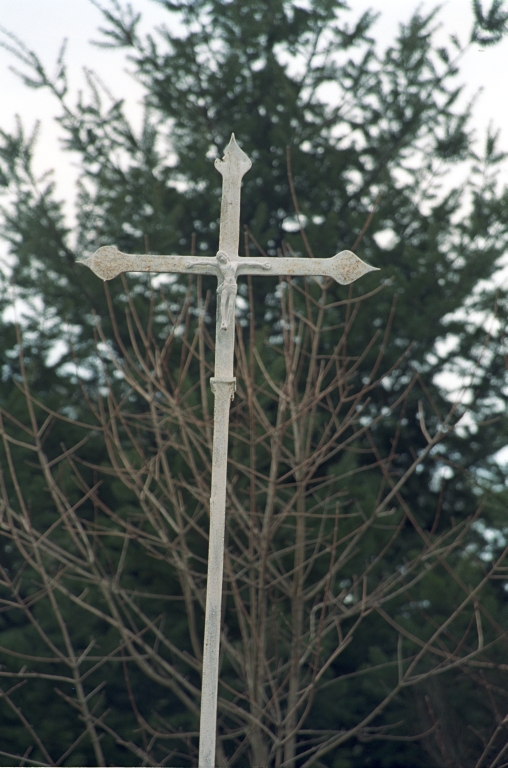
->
[0,0,508,228]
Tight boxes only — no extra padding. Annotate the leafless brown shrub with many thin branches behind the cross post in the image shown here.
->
[0,268,505,767]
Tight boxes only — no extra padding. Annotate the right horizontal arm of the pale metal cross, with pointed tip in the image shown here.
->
[238,251,378,285]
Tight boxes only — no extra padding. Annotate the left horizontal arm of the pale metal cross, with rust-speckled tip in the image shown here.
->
[78,245,218,280]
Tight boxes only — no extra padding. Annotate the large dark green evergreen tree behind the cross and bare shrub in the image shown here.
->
[0,0,508,766]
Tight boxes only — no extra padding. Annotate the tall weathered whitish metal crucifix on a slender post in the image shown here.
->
[80,134,375,768]
